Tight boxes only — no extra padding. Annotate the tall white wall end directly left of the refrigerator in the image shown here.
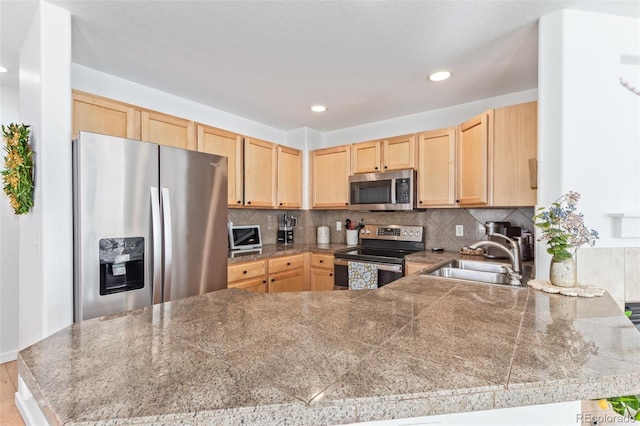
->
[18,2,73,349]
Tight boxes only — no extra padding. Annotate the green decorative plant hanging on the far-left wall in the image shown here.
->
[2,123,34,214]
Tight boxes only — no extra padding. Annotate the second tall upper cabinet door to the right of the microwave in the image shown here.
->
[457,112,492,206]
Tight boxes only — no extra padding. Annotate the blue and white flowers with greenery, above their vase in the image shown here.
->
[533,191,599,261]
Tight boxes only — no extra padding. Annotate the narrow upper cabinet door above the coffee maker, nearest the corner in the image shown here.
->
[278,146,302,209]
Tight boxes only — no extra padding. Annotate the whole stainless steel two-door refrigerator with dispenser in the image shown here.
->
[72,132,227,322]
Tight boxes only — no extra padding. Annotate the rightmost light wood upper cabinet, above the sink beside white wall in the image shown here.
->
[457,102,538,207]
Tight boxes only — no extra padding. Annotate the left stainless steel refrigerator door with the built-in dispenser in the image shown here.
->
[73,132,159,322]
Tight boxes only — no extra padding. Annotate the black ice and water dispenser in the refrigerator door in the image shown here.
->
[99,237,144,296]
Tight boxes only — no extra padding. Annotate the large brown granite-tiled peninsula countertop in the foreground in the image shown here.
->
[18,268,640,425]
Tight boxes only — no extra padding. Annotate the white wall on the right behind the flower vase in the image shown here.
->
[536,10,640,278]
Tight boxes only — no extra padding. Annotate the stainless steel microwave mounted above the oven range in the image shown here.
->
[349,170,417,210]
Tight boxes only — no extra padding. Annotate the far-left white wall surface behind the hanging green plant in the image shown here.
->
[0,86,20,364]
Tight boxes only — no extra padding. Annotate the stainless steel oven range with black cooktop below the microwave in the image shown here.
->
[333,225,425,288]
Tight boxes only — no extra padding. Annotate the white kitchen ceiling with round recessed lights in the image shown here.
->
[0,0,640,132]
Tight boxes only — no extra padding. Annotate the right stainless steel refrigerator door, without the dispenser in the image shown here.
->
[160,146,227,302]
